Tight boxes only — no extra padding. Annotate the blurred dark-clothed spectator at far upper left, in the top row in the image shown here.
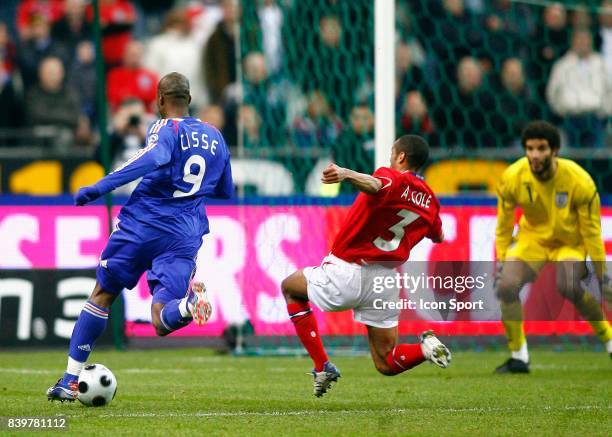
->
[17,15,69,89]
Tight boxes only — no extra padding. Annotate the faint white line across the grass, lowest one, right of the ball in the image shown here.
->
[61,405,612,418]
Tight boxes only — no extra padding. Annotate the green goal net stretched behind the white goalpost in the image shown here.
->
[204,0,612,351]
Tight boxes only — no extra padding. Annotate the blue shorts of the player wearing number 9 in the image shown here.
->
[96,222,202,303]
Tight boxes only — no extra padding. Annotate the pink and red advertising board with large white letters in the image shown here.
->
[0,205,612,336]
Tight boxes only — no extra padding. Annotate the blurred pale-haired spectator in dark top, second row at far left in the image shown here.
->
[26,57,81,141]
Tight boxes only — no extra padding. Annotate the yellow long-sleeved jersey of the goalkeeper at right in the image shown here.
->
[495,157,606,261]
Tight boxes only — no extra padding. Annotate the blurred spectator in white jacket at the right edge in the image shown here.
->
[546,29,612,147]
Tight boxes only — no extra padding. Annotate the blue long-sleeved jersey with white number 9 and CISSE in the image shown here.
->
[96,117,233,237]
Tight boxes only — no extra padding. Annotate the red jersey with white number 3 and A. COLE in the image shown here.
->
[332,167,442,265]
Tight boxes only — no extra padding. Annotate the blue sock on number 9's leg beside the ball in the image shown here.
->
[62,301,108,383]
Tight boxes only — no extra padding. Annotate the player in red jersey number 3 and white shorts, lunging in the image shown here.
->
[281,135,451,396]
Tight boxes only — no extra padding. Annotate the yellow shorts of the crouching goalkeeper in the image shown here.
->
[506,237,587,272]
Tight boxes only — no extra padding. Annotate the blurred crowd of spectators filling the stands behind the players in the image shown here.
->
[0,0,612,164]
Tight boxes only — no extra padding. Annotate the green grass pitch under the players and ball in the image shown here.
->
[0,349,612,436]
